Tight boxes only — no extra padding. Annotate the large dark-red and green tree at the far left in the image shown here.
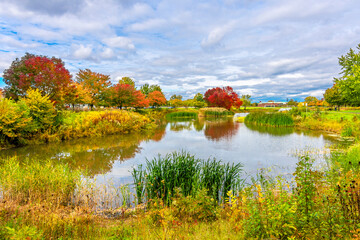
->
[3,53,72,103]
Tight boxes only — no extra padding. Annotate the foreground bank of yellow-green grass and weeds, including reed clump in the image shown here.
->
[0,144,360,239]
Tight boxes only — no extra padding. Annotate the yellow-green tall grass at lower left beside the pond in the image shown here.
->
[0,158,81,206]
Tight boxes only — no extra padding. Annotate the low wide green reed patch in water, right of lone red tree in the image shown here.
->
[245,112,294,127]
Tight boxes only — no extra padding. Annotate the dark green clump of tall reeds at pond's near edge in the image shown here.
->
[132,151,242,204]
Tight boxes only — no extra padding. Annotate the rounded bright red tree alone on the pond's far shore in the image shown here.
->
[204,86,242,110]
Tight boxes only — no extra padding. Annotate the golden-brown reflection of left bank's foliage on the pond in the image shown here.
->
[0,131,160,176]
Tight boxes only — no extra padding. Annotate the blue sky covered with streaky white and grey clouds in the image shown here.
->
[0,0,360,101]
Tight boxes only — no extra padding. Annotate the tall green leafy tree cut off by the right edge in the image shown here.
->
[334,44,360,106]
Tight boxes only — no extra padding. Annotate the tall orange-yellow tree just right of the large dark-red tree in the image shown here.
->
[76,69,111,108]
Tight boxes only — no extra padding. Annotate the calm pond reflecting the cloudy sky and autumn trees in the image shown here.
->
[0,118,344,185]
